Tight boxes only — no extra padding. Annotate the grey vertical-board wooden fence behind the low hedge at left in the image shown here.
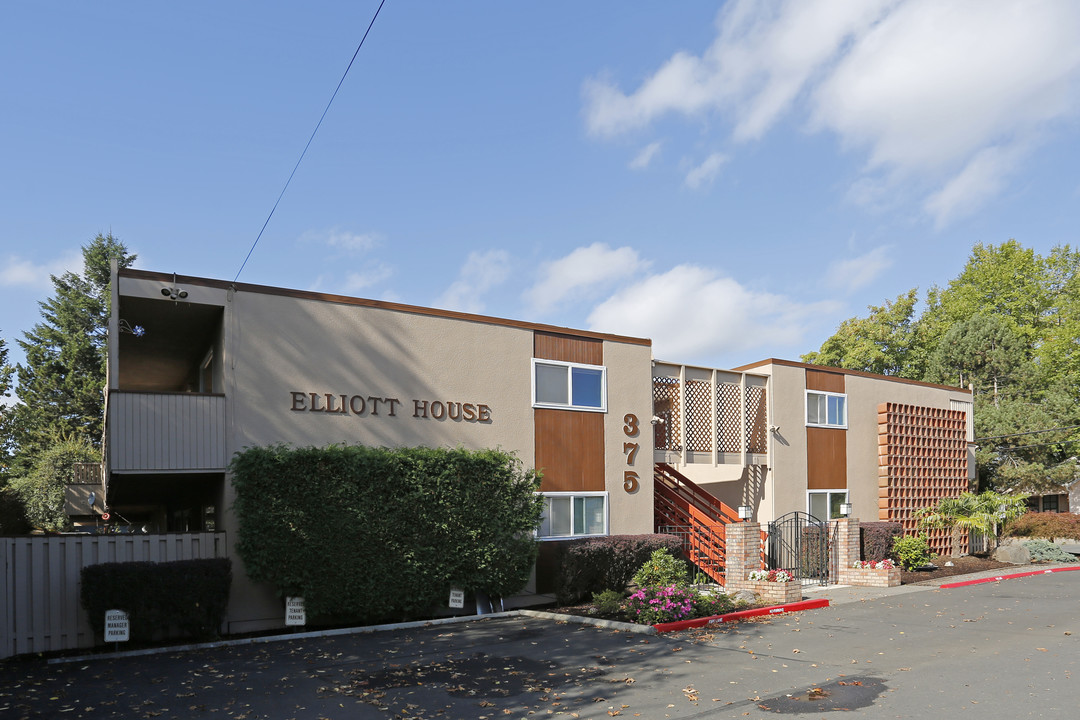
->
[0,532,228,658]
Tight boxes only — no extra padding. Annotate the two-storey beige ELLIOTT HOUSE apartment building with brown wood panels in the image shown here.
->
[92,263,974,633]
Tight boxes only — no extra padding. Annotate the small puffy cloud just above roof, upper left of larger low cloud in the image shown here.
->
[525,243,648,314]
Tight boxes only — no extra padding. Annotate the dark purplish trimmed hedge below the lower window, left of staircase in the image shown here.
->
[555,535,683,604]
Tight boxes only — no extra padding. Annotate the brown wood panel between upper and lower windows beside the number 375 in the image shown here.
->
[534,408,605,492]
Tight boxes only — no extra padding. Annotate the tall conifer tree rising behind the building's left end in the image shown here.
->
[11,233,135,475]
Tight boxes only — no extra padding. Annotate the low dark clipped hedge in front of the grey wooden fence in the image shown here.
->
[80,558,232,641]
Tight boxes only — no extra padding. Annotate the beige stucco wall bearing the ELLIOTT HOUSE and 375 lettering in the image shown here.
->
[119,277,652,633]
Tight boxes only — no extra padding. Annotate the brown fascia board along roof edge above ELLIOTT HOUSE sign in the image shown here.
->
[118,268,652,347]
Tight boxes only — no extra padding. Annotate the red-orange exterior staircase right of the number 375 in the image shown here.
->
[652,462,742,585]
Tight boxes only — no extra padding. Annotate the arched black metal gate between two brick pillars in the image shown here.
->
[765,512,837,585]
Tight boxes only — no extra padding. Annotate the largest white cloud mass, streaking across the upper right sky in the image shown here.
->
[582,0,1080,226]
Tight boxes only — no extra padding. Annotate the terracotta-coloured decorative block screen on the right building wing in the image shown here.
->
[878,403,968,555]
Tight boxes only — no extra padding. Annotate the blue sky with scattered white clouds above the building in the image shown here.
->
[0,0,1080,377]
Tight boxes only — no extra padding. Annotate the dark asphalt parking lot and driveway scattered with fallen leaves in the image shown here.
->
[0,572,1080,720]
